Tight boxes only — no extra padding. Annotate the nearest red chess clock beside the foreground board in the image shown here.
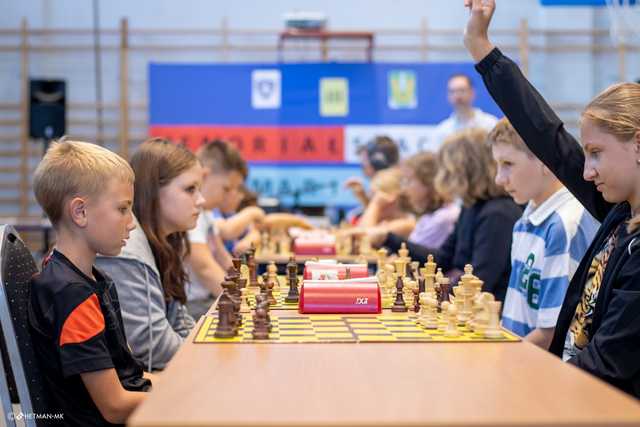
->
[299,277,382,314]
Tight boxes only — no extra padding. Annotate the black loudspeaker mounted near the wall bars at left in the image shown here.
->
[29,79,67,140]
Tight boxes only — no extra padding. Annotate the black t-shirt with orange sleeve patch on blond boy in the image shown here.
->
[29,251,151,426]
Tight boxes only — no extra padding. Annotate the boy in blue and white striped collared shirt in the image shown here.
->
[488,118,599,349]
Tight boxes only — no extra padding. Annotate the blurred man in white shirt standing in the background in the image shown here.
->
[433,74,498,149]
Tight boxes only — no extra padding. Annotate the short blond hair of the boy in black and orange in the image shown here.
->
[33,137,135,226]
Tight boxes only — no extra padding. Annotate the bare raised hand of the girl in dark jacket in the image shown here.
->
[464,0,496,62]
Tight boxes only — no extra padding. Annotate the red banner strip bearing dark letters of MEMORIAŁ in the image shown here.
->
[149,126,344,163]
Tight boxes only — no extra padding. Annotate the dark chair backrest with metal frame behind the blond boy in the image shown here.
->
[0,226,48,426]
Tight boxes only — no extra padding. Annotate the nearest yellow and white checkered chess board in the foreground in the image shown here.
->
[194,313,520,344]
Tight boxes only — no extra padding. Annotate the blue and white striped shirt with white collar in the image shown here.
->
[502,188,600,336]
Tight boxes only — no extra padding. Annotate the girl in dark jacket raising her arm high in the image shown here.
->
[465,0,640,397]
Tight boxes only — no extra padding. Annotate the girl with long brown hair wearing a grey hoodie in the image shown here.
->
[97,138,199,371]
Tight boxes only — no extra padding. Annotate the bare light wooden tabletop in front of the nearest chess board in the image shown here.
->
[130,312,640,427]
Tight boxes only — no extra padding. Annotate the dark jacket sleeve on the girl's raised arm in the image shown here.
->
[476,48,613,222]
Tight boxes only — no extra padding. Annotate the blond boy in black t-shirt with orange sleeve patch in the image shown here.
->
[29,140,151,426]
